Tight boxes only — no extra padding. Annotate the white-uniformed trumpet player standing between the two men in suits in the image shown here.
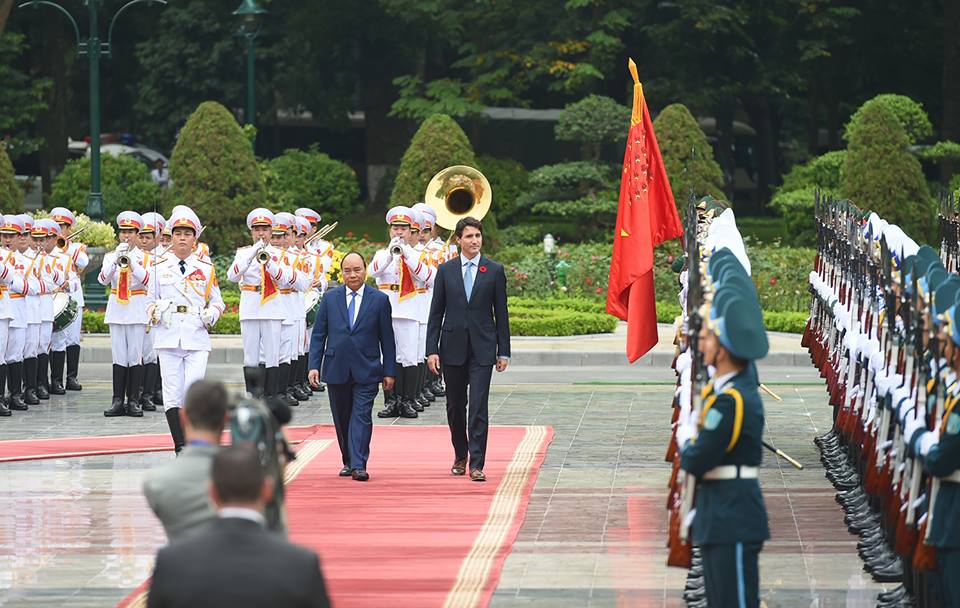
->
[367,206,434,418]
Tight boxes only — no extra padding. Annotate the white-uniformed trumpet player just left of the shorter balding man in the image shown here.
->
[227,207,293,396]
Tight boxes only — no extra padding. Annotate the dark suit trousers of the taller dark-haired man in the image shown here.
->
[441,356,493,469]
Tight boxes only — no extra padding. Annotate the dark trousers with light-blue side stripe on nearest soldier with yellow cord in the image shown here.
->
[700,543,763,608]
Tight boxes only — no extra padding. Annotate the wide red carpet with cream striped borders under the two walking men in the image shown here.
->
[120,426,553,608]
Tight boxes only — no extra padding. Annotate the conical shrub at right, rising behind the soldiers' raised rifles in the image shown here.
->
[840,104,934,241]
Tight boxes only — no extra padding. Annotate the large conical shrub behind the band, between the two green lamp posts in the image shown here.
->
[167,101,270,253]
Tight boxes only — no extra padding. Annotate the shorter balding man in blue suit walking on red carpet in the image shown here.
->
[308,252,397,481]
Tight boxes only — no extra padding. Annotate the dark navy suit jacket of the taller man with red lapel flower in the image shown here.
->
[427,255,510,365]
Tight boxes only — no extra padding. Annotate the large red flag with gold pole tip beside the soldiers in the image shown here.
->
[607,59,683,363]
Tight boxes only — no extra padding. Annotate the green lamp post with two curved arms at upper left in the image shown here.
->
[17,0,167,221]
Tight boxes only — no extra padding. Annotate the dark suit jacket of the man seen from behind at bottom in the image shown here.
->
[147,518,330,608]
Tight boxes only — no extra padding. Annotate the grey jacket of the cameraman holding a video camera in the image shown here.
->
[143,445,219,542]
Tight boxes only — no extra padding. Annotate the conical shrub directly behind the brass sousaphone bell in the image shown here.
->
[390,114,476,205]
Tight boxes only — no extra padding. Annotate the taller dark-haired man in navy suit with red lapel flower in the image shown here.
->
[427,217,510,481]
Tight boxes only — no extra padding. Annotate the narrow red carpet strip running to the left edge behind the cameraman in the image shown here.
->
[0,425,324,462]
